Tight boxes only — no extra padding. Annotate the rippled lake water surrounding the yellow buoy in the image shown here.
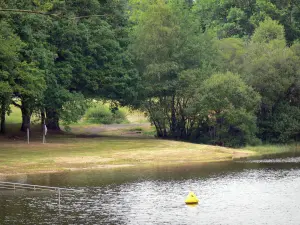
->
[0,157,300,225]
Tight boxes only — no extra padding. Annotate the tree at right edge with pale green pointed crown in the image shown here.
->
[244,19,299,141]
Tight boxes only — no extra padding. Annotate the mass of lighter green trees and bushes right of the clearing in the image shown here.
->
[130,0,300,146]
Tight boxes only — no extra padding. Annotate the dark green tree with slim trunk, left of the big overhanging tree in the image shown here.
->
[3,0,54,131]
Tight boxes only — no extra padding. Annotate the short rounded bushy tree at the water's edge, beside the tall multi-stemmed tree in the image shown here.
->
[198,72,260,146]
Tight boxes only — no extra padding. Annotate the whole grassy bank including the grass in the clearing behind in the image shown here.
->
[0,106,300,175]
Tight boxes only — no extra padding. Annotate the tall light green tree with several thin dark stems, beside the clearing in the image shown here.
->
[131,0,217,139]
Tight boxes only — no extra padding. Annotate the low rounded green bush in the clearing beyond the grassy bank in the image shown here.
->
[85,105,128,124]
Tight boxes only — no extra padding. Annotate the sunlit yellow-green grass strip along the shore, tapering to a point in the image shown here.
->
[0,135,250,174]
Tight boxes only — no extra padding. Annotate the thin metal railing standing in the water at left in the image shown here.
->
[0,182,82,207]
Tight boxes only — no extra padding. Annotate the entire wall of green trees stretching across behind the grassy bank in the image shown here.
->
[0,0,300,146]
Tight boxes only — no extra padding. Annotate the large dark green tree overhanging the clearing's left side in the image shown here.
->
[44,1,137,130]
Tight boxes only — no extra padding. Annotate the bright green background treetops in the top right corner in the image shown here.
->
[196,0,300,45]
